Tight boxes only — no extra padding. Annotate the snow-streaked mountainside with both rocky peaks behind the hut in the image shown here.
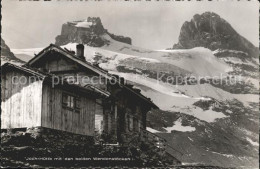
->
[7,12,259,167]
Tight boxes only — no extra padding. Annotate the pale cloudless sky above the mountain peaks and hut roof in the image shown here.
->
[1,0,259,50]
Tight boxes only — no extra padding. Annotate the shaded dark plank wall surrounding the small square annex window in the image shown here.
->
[42,85,96,136]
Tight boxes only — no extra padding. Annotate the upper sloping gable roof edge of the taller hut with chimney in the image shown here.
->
[26,44,158,108]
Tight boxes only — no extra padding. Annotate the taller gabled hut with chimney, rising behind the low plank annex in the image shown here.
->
[24,44,158,142]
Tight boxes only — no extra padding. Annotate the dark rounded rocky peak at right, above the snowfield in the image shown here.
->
[173,12,258,58]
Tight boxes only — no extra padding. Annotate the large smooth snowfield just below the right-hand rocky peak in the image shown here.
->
[152,47,233,76]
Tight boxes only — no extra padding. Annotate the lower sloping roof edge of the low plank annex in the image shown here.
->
[1,63,110,97]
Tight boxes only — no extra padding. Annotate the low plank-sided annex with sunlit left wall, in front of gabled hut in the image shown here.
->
[1,63,106,136]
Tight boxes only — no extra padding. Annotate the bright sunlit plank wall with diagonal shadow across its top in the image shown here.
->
[1,71,42,129]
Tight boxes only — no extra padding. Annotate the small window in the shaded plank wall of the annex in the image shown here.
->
[62,93,80,110]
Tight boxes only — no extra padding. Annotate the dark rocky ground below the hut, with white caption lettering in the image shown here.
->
[1,127,177,168]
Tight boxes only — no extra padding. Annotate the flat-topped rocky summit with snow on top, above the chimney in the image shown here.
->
[55,17,132,47]
